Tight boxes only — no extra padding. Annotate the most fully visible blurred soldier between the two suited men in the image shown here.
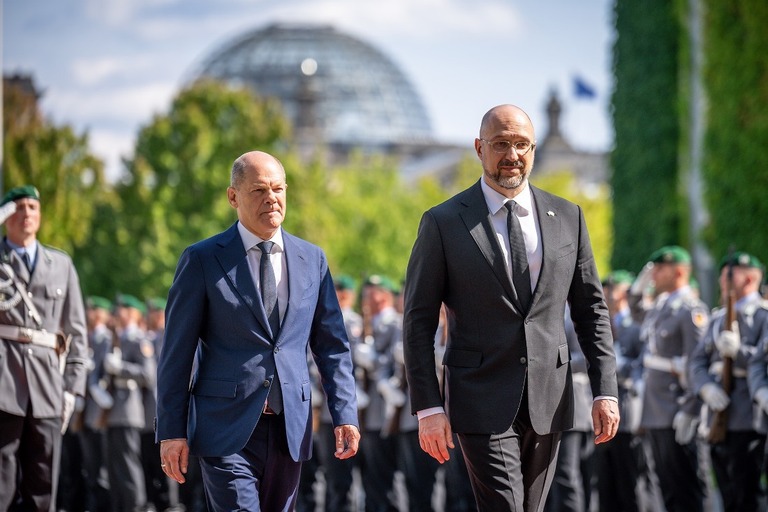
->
[353,275,405,512]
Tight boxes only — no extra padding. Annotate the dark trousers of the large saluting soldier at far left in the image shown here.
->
[0,411,61,511]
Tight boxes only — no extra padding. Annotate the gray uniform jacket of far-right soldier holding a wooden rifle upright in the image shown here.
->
[689,294,768,431]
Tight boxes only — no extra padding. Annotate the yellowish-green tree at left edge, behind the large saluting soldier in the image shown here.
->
[3,77,106,253]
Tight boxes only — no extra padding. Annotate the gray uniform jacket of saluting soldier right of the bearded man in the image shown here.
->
[640,287,709,428]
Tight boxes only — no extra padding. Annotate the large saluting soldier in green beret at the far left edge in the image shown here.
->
[0,185,88,511]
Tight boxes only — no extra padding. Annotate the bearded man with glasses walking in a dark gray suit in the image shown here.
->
[404,105,619,512]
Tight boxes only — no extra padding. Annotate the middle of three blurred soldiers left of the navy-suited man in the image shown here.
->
[103,295,156,512]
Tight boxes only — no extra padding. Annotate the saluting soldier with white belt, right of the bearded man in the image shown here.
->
[631,246,708,512]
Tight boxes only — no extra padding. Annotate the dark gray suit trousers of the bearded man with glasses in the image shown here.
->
[459,403,561,512]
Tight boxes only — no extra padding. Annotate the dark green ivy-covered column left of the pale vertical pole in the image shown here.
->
[611,0,685,271]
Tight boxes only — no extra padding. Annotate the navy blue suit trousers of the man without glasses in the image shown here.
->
[200,414,301,512]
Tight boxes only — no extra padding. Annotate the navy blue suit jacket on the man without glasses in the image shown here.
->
[157,224,357,461]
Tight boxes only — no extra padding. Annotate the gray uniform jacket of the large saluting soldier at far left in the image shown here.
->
[0,240,88,418]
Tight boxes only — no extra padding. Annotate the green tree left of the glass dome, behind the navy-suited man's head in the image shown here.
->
[77,81,290,296]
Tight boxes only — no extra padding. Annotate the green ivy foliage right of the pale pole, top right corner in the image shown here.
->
[702,0,768,262]
